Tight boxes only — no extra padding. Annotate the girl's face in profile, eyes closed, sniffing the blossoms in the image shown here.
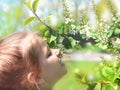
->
[40,37,66,84]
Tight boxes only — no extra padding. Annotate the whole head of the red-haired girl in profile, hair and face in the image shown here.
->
[0,32,66,90]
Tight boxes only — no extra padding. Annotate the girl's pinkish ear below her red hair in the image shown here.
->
[27,72,44,84]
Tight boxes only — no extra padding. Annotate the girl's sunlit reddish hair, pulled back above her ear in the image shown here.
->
[0,32,41,90]
